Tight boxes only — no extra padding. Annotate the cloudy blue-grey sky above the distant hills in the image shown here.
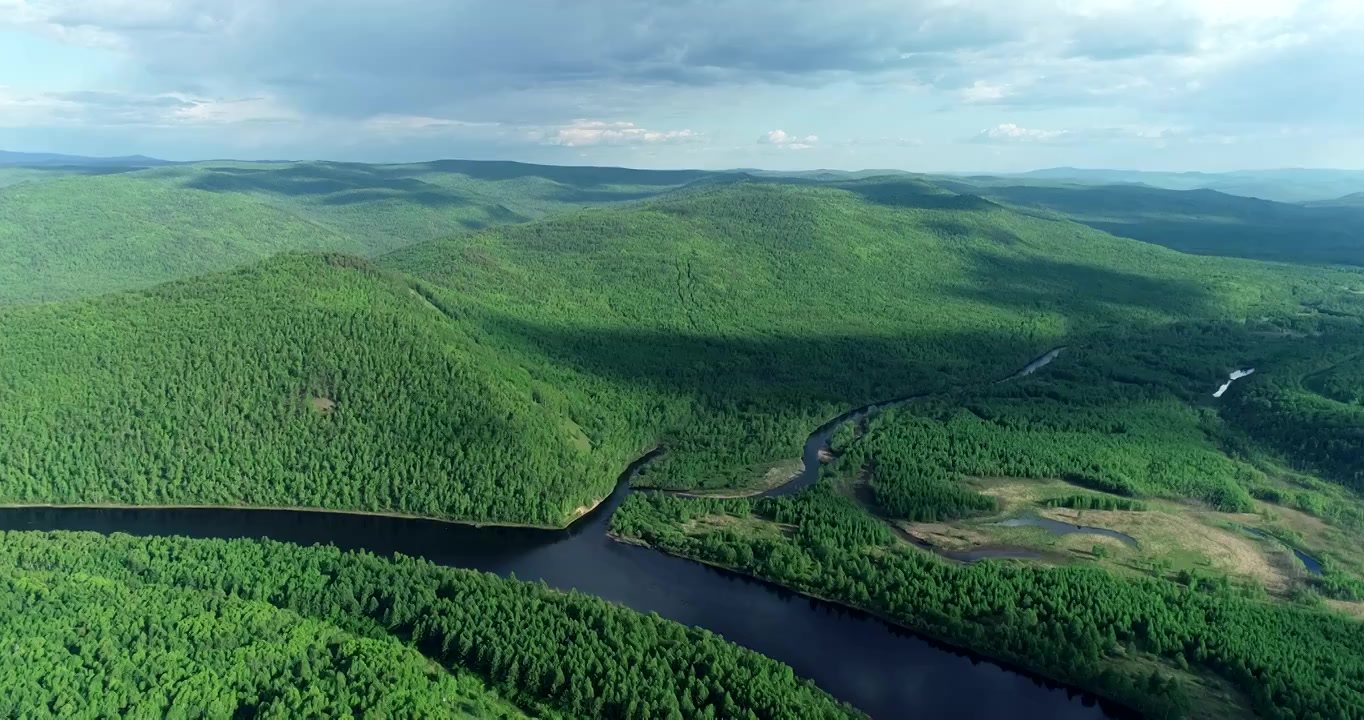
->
[0,0,1364,172]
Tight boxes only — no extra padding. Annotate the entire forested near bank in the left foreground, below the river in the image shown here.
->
[0,532,857,720]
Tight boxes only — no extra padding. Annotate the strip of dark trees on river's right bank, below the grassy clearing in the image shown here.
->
[612,488,1364,720]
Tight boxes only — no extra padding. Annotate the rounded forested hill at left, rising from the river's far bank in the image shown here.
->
[0,256,619,525]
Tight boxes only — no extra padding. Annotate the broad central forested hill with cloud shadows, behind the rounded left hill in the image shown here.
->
[383,179,1364,496]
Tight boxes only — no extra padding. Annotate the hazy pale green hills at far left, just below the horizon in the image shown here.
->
[0,161,704,304]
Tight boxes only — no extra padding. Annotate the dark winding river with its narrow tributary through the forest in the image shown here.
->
[0,347,1125,720]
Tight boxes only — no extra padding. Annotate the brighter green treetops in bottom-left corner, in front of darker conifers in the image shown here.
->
[0,559,525,719]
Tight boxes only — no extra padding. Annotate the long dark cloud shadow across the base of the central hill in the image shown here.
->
[484,316,1046,415]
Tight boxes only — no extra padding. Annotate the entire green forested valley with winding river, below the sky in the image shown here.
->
[0,162,1364,717]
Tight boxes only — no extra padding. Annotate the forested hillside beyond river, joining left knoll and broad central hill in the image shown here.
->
[0,180,1357,525]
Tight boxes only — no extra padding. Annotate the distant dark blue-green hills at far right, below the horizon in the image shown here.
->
[941,179,1364,266]
